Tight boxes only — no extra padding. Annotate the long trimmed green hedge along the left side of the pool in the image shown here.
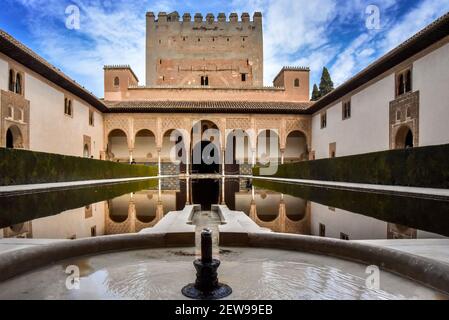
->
[0,148,157,186]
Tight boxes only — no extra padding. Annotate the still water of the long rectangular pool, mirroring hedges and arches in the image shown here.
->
[0,178,449,240]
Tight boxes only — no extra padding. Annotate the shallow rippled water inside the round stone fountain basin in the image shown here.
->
[0,247,448,300]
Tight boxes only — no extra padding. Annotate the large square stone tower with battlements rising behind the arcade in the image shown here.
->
[146,12,263,88]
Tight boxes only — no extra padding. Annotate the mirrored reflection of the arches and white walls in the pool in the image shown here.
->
[0,178,444,240]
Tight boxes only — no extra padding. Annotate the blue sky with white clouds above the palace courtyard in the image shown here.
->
[0,0,449,97]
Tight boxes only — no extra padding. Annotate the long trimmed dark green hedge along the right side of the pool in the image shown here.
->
[254,145,449,189]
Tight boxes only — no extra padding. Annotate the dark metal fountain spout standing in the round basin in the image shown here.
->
[182,229,232,300]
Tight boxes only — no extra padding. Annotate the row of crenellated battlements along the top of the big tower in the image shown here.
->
[146,11,262,24]
